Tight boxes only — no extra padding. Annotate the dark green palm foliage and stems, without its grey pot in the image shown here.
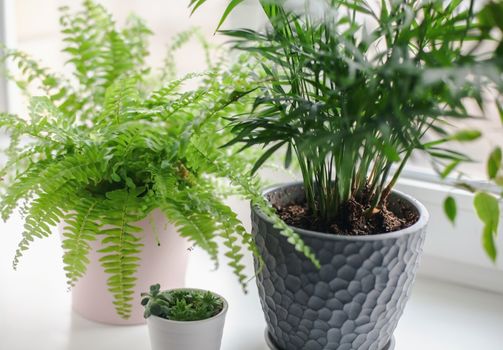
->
[190,0,501,234]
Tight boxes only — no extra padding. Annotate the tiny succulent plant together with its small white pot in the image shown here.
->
[142,284,228,350]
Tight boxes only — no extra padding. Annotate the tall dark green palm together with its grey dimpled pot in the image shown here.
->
[191,0,501,350]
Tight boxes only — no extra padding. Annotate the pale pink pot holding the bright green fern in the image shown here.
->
[60,210,189,325]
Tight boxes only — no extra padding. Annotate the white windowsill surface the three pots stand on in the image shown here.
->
[0,205,503,350]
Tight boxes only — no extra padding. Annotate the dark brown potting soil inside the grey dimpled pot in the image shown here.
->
[275,194,419,236]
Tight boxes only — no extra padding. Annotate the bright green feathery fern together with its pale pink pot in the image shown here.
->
[0,1,253,324]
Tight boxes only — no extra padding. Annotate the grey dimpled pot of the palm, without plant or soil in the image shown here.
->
[252,183,429,350]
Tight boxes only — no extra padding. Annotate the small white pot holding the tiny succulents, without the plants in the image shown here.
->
[147,288,228,350]
